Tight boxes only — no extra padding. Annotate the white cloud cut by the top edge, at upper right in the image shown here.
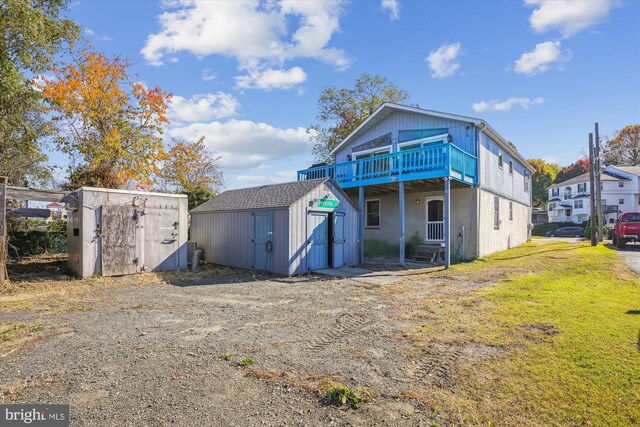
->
[525,0,619,37]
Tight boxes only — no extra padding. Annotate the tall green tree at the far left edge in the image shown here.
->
[0,0,80,185]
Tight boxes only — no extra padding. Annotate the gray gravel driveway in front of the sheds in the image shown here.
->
[0,262,496,426]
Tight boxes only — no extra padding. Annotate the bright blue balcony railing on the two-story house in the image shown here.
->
[298,142,477,188]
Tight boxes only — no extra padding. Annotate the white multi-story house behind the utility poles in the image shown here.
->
[547,166,640,224]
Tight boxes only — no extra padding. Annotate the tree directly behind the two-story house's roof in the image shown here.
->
[307,74,409,161]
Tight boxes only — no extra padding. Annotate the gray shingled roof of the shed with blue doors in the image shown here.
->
[191,178,329,213]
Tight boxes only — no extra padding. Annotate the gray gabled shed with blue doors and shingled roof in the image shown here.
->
[191,178,358,275]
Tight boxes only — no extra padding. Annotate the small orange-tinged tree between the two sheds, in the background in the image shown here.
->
[159,137,223,209]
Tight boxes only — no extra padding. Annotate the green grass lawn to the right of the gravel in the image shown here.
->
[410,242,640,426]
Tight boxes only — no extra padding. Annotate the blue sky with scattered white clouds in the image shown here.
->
[51,0,640,188]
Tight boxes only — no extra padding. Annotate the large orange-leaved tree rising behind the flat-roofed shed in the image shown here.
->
[42,46,171,188]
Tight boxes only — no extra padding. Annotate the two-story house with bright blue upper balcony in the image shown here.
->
[298,103,534,265]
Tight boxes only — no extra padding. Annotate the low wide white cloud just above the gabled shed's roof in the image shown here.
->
[167,119,313,170]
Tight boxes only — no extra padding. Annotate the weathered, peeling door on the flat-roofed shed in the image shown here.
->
[101,206,138,276]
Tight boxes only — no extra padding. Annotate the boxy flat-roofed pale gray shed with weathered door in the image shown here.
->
[63,187,188,277]
